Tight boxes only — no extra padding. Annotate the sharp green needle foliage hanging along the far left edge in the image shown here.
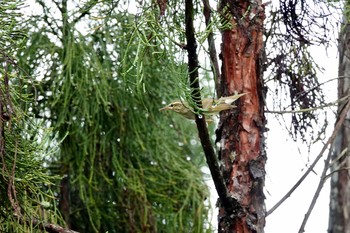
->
[0,0,62,232]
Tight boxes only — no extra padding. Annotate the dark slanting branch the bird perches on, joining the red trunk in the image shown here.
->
[185,0,240,213]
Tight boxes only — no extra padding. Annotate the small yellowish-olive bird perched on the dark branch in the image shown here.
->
[159,93,247,122]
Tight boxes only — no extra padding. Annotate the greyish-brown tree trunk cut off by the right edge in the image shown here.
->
[328,20,350,233]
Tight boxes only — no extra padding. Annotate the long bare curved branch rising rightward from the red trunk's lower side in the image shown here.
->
[266,98,350,216]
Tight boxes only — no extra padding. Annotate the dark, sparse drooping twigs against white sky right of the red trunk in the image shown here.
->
[264,0,340,144]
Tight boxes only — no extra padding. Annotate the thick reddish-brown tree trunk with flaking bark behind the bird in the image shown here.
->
[217,0,266,232]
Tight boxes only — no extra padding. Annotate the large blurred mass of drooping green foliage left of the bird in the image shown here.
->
[20,0,208,232]
